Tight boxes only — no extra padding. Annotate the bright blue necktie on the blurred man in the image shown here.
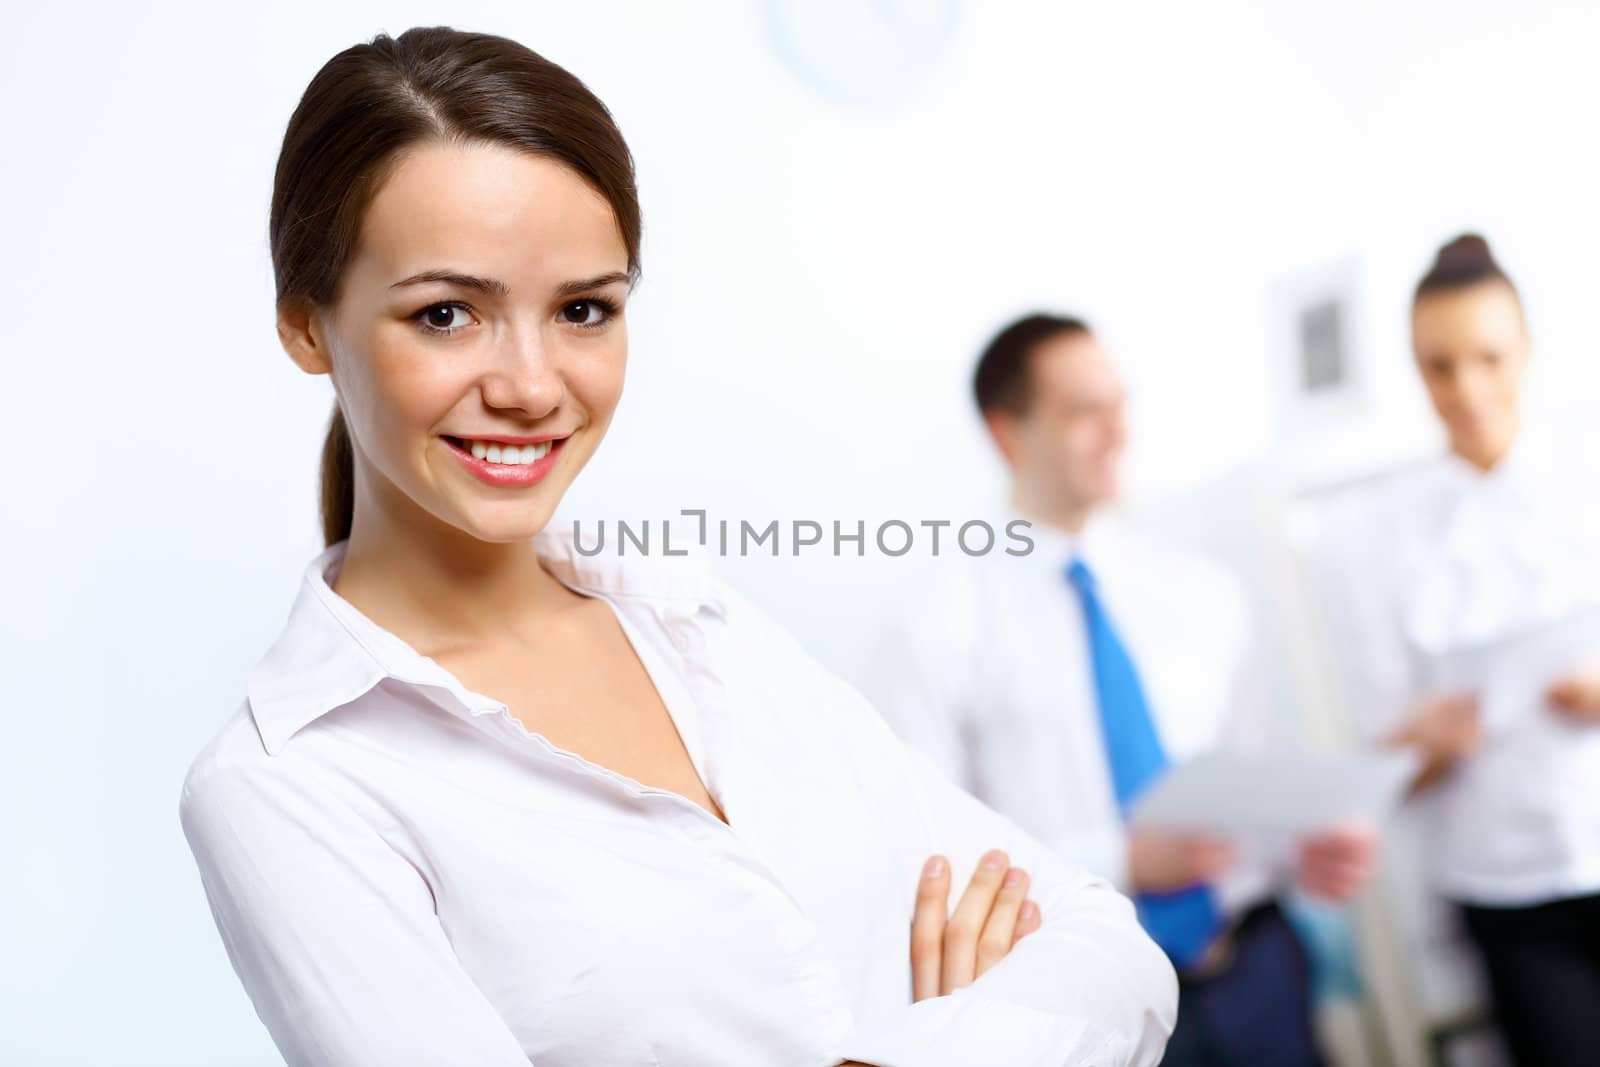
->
[1067,560,1221,966]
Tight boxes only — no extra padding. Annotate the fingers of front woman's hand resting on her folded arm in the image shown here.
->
[910,849,1043,1001]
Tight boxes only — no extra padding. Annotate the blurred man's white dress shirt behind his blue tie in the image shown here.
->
[870,512,1285,913]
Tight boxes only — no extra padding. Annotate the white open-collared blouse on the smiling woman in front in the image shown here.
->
[179,530,1176,1067]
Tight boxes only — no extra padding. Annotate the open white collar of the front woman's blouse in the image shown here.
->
[245,522,726,755]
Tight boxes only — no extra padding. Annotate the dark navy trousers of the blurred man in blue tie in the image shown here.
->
[1162,904,1323,1067]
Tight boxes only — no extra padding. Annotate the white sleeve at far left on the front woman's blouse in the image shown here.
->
[179,765,530,1067]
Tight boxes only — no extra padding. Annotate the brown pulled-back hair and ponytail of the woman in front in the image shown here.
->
[269,26,642,544]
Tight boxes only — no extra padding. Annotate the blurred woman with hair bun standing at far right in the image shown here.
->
[1318,235,1600,1067]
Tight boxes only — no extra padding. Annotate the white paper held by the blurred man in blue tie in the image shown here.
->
[1131,750,1418,837]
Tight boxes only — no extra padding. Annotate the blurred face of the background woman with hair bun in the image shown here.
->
[1411,282,1530,470]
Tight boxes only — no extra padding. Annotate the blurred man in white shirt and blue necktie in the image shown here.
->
[877,315,1373,1067]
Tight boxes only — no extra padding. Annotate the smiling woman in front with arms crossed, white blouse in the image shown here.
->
[181,27,1176,1067]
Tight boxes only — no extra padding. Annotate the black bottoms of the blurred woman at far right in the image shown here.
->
[1461,896,1600,1067]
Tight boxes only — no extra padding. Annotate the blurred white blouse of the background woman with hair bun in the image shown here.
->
[1315,429,1600,905]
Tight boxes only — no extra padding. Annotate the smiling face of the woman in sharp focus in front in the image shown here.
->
[280,136,629,542]
